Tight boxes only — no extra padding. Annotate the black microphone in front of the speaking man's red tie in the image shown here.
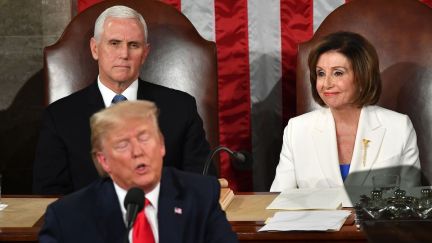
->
[124,187,144,231]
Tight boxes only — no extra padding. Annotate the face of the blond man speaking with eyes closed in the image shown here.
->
[96,118,165,192]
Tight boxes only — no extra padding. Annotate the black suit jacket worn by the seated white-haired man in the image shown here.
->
[33,80,216,194]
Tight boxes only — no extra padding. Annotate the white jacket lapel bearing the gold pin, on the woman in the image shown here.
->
[345,106,386,185]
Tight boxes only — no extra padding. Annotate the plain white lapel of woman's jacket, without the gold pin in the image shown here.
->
[311,109,343,187]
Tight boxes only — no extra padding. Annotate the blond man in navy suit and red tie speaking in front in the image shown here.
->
[39,101,237,243]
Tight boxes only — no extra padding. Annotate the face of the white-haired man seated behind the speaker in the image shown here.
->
[90,17,149,91]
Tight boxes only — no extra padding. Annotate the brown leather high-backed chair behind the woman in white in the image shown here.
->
[296,0,432,184]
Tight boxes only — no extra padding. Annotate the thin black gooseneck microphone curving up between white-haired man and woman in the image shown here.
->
[202,146,253,175]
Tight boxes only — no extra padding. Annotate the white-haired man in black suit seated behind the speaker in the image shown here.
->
[33,6,216,194]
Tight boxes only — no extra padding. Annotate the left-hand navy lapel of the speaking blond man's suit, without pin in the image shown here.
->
[93,178,126,242]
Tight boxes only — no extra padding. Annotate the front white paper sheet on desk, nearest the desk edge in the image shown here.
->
[259,210,351,231]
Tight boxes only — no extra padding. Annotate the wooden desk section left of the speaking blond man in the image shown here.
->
[0,196,57,242]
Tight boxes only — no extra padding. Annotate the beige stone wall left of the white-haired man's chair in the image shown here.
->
[0,0,72,110]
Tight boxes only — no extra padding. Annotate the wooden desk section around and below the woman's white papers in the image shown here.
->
[226,192,367,242]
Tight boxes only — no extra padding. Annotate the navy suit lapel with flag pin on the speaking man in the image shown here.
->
[158,168,188,243]
